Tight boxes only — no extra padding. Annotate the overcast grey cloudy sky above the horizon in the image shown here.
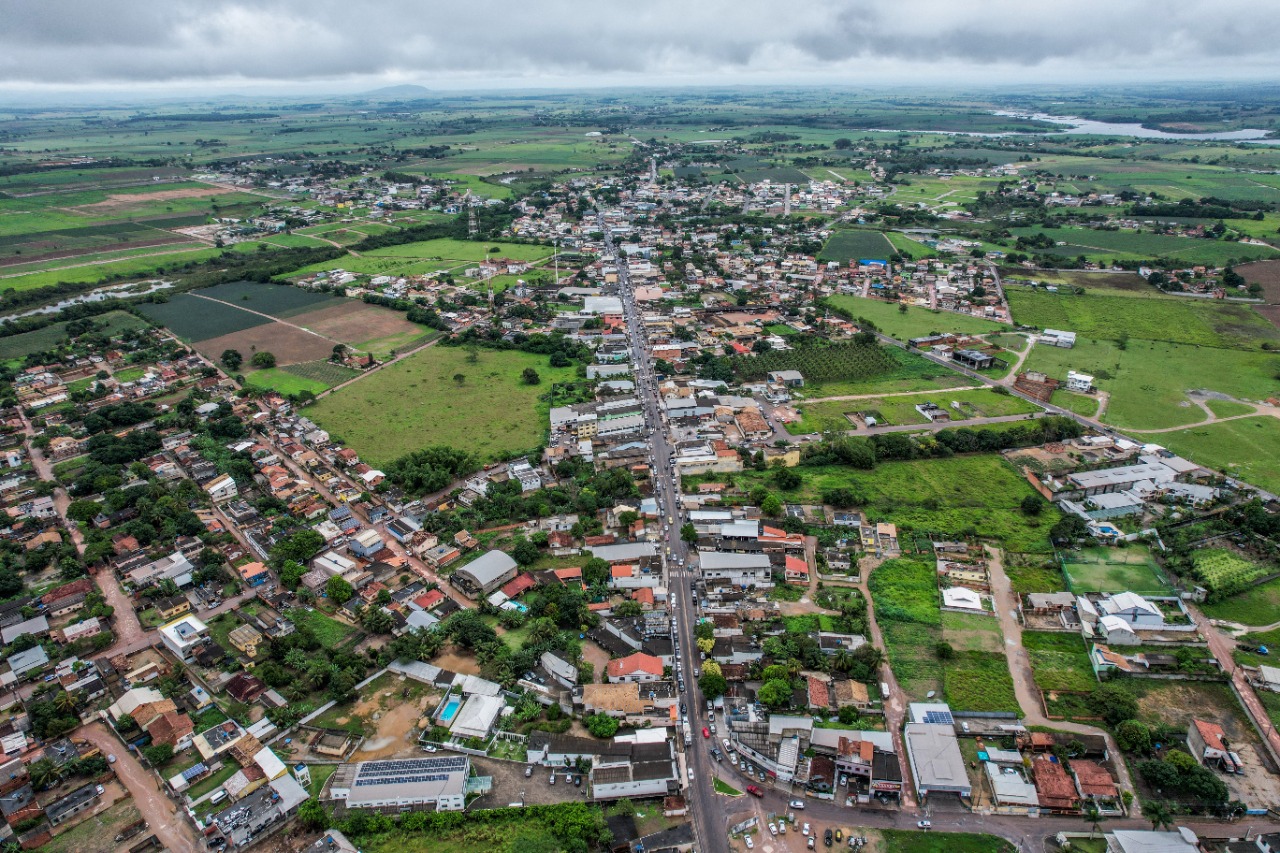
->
[0,0,1280,92]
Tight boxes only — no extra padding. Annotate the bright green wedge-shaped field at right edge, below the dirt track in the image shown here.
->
[1146,415,1280,492]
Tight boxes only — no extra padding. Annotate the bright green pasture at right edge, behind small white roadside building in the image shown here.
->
[1023,327,1280,427]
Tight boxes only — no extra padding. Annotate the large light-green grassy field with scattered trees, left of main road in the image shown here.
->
[307,346,573,464]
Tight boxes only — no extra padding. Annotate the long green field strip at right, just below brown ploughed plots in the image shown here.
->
[1006,287,1280,350]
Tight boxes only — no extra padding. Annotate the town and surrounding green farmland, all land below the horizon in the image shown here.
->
[0,11,1280,853]
